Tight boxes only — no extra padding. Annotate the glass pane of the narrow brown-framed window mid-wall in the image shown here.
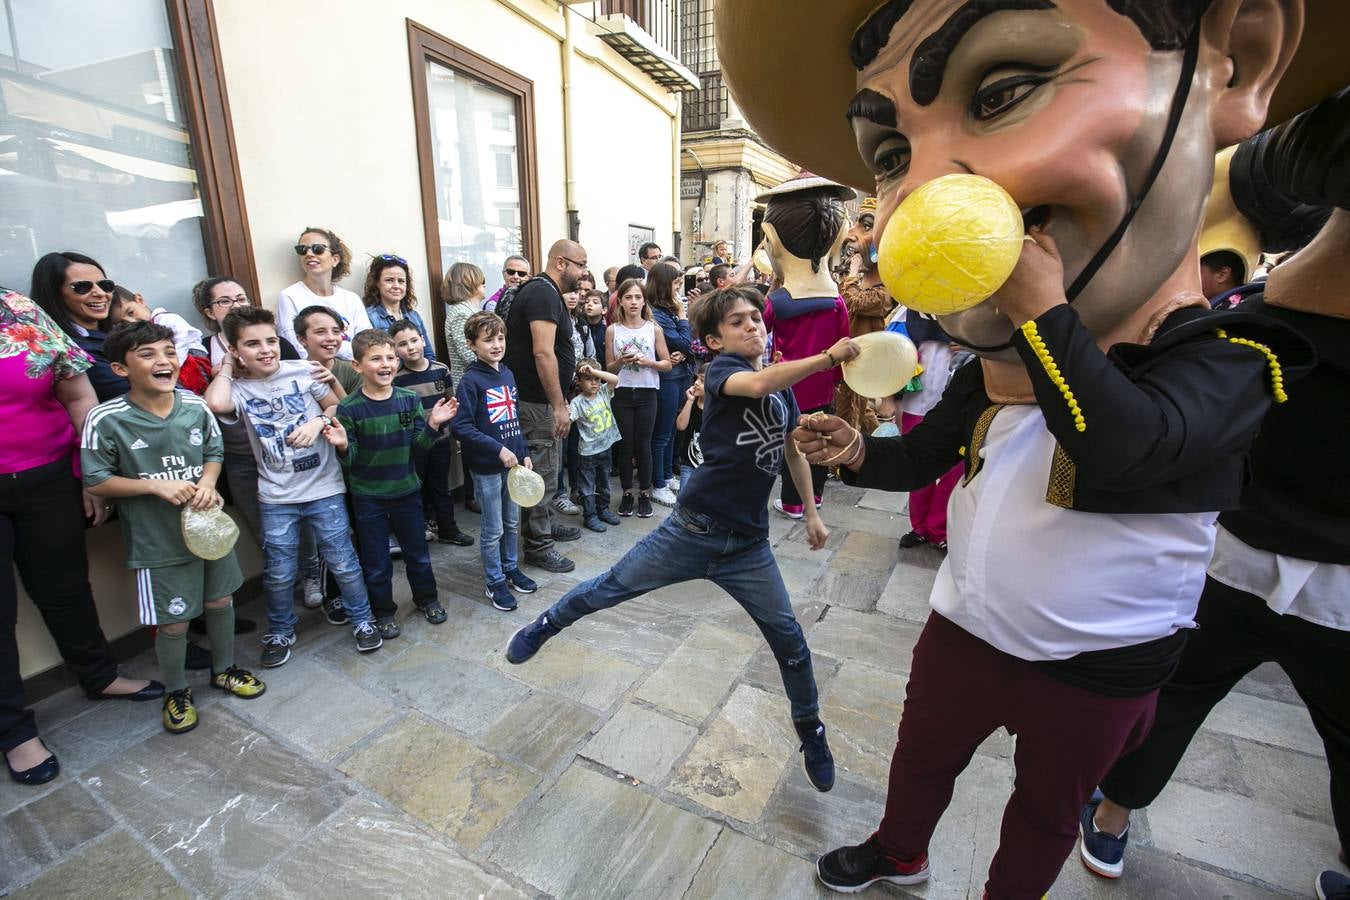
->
[427,61,522,294]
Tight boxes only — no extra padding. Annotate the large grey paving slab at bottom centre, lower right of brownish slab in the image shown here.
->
[491,765,721,900]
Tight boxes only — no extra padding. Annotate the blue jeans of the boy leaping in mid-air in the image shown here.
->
[547,505,819,722]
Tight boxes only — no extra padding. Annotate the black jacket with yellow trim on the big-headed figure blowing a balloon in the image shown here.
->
[842,305,1316,514]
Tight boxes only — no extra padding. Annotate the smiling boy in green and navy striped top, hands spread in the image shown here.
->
[324,328,459,638]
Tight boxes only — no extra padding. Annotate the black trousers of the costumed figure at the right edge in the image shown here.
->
[1102,579,1350,855]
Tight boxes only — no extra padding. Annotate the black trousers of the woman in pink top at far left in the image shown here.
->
[0,457,117,752]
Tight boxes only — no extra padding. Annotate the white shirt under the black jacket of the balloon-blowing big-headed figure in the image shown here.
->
[929,406,1218,660]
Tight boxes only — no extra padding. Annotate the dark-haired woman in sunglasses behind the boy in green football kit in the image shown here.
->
[28,250,130,403]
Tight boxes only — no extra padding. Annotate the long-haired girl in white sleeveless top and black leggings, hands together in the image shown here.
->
[606,278,671,518]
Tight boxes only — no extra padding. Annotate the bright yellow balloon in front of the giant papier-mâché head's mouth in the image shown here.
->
[878,175,1023,316]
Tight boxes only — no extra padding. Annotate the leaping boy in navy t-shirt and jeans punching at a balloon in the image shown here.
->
[506,287,857,791]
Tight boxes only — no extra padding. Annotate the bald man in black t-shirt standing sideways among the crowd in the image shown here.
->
[505,240,587,572]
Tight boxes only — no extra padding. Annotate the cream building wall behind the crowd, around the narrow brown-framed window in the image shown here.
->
[18,0,678,677]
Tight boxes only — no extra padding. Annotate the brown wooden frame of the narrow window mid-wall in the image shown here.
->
[406,19,540,359]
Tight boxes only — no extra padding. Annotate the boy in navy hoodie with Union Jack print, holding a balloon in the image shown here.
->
[450,312,539,611]
